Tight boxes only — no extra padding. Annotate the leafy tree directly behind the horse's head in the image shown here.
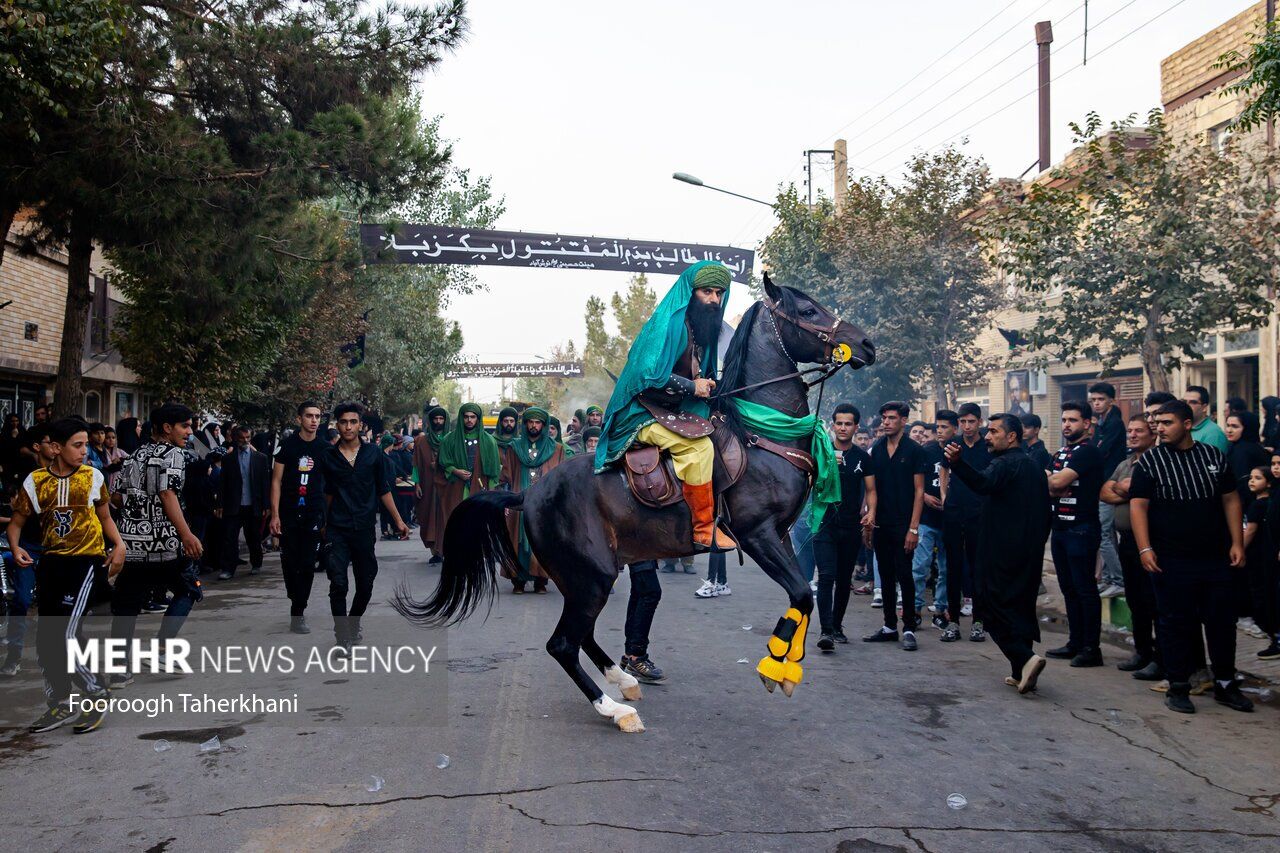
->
[763,147,1000,409]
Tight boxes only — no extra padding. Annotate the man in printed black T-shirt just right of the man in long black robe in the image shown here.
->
[1044,401,1103,666]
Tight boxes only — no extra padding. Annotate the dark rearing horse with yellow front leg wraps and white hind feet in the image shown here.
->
[393,277,876,731]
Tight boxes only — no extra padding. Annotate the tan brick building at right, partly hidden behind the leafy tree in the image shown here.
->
[952,3,1277,450]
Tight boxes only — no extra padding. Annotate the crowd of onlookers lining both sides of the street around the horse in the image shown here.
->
[0,382,1280,731]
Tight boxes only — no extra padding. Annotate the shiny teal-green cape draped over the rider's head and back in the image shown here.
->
[588,261,732,474]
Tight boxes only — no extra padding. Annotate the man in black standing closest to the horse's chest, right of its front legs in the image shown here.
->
[813,403,876,652]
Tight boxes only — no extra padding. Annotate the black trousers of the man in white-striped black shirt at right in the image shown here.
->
[1151,555,1240,683]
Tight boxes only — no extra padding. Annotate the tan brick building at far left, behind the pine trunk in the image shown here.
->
[0,222,150,424]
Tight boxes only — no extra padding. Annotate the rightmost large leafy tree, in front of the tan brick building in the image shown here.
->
[991,109,1280,391]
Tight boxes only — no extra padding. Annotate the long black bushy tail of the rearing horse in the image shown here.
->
[392,492,525,628]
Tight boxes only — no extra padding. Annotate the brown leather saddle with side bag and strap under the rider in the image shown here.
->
[622,412,818,510]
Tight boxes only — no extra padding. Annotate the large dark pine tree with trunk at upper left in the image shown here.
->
[4,0,465,412]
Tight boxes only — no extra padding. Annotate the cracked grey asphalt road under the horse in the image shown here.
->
[0,542,1280,852]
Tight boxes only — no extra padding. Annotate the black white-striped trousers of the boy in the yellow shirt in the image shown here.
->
[36,553,109,708]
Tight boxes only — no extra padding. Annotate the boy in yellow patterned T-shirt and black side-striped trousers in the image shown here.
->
[9,418,124,734]
